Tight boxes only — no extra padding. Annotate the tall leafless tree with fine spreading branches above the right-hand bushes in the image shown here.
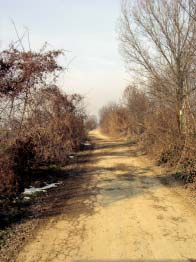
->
[120,0,196,129]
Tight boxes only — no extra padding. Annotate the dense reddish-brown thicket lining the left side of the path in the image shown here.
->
[0,47,86,201]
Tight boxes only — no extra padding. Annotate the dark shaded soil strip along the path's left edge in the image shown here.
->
[0,146,94,262]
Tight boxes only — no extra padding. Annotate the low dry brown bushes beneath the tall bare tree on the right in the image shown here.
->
[100,84,196,182]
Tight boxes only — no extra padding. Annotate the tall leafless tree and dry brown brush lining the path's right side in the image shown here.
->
[100,0,196,182]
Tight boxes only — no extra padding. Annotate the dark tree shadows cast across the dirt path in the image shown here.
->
[21,136,179,218]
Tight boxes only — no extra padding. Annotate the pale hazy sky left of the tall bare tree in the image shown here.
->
[0,0,128,114]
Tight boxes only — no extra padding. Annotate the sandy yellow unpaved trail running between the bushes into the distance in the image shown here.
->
[16,130,196,262]
